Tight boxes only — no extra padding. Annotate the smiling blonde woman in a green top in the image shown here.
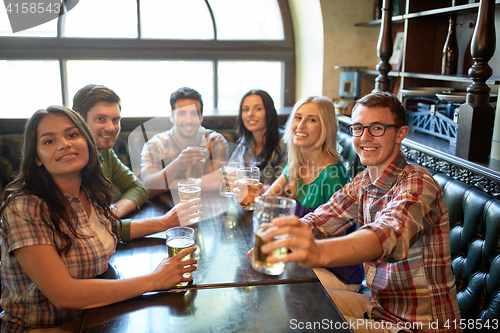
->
[265,96,364,291]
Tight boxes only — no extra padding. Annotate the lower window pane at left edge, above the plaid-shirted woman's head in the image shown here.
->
[0,60,62,118]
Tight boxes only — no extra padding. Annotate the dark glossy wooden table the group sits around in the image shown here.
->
[81,196,351,333]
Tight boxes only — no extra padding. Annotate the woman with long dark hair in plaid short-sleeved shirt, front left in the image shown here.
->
[0,106,196,332]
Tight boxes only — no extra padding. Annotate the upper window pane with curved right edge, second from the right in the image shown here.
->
[141,0,214,39]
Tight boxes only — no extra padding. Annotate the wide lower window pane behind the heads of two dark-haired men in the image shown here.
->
[67,60,213,117]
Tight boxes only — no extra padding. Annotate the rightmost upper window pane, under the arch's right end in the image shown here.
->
[208,0,284,40]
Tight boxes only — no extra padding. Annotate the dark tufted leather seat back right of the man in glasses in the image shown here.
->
[434,173,500,326]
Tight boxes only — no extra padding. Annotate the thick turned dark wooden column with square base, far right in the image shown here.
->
[455,0,496,162]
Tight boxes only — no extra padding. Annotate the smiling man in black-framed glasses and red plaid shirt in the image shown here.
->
[262,92,460,332]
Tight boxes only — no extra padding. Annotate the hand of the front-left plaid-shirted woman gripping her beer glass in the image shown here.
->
[151,246,197,290]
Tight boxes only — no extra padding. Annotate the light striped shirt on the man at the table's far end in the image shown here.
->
[141,127,227,185]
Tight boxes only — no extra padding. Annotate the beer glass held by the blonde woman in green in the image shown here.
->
[236,167,260,210]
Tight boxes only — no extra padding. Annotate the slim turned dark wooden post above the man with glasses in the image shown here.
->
[375,0,392,91]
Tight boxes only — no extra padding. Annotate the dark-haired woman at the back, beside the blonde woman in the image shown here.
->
[229,89,287,186]
